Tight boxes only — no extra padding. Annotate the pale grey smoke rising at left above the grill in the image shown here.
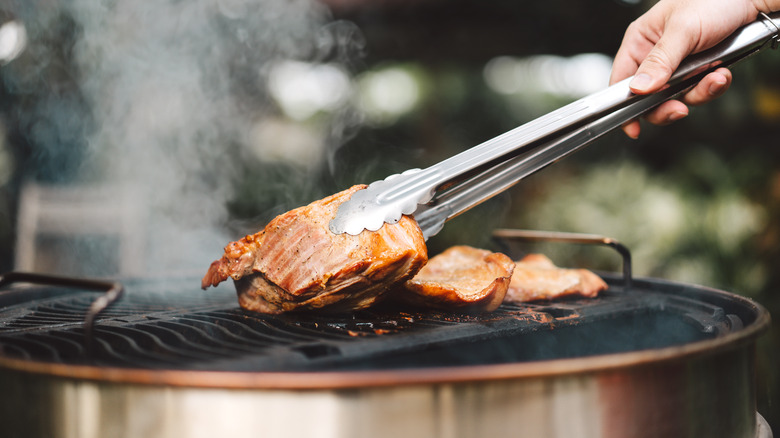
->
[29,0,360,275]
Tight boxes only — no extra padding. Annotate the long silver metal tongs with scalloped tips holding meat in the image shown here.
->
[330,12,780,239]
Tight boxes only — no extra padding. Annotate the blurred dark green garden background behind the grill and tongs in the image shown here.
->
[0,0,780,432]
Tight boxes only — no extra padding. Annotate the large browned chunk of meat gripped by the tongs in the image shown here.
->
[202,186,428,313]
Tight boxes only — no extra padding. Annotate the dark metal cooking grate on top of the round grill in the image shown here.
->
[0,276,741,371]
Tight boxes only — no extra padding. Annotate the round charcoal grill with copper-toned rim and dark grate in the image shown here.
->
[0,234,771,437]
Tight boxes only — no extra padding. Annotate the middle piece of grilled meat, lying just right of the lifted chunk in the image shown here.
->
[393,245,514,312]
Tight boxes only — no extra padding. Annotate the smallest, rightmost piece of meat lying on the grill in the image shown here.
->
[504,254,607,303]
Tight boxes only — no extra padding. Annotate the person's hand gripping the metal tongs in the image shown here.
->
[610,0,764,138]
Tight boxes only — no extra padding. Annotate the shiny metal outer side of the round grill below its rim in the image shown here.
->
[0,346,759,438]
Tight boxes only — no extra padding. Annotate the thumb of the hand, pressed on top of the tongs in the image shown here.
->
[628,32,690,94]
